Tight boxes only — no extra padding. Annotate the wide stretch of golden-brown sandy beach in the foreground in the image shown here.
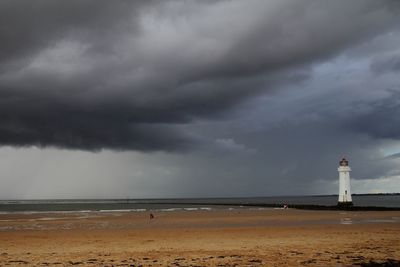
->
[0,209,400,266]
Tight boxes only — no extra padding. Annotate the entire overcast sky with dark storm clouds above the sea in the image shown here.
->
[0,0,400,199]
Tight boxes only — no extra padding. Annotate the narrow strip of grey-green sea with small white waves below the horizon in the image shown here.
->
[0,194,400,214]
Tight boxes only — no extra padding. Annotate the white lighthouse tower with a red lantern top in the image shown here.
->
[338,158,353,207]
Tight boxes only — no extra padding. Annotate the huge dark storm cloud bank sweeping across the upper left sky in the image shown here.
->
[0,0,399,151]
